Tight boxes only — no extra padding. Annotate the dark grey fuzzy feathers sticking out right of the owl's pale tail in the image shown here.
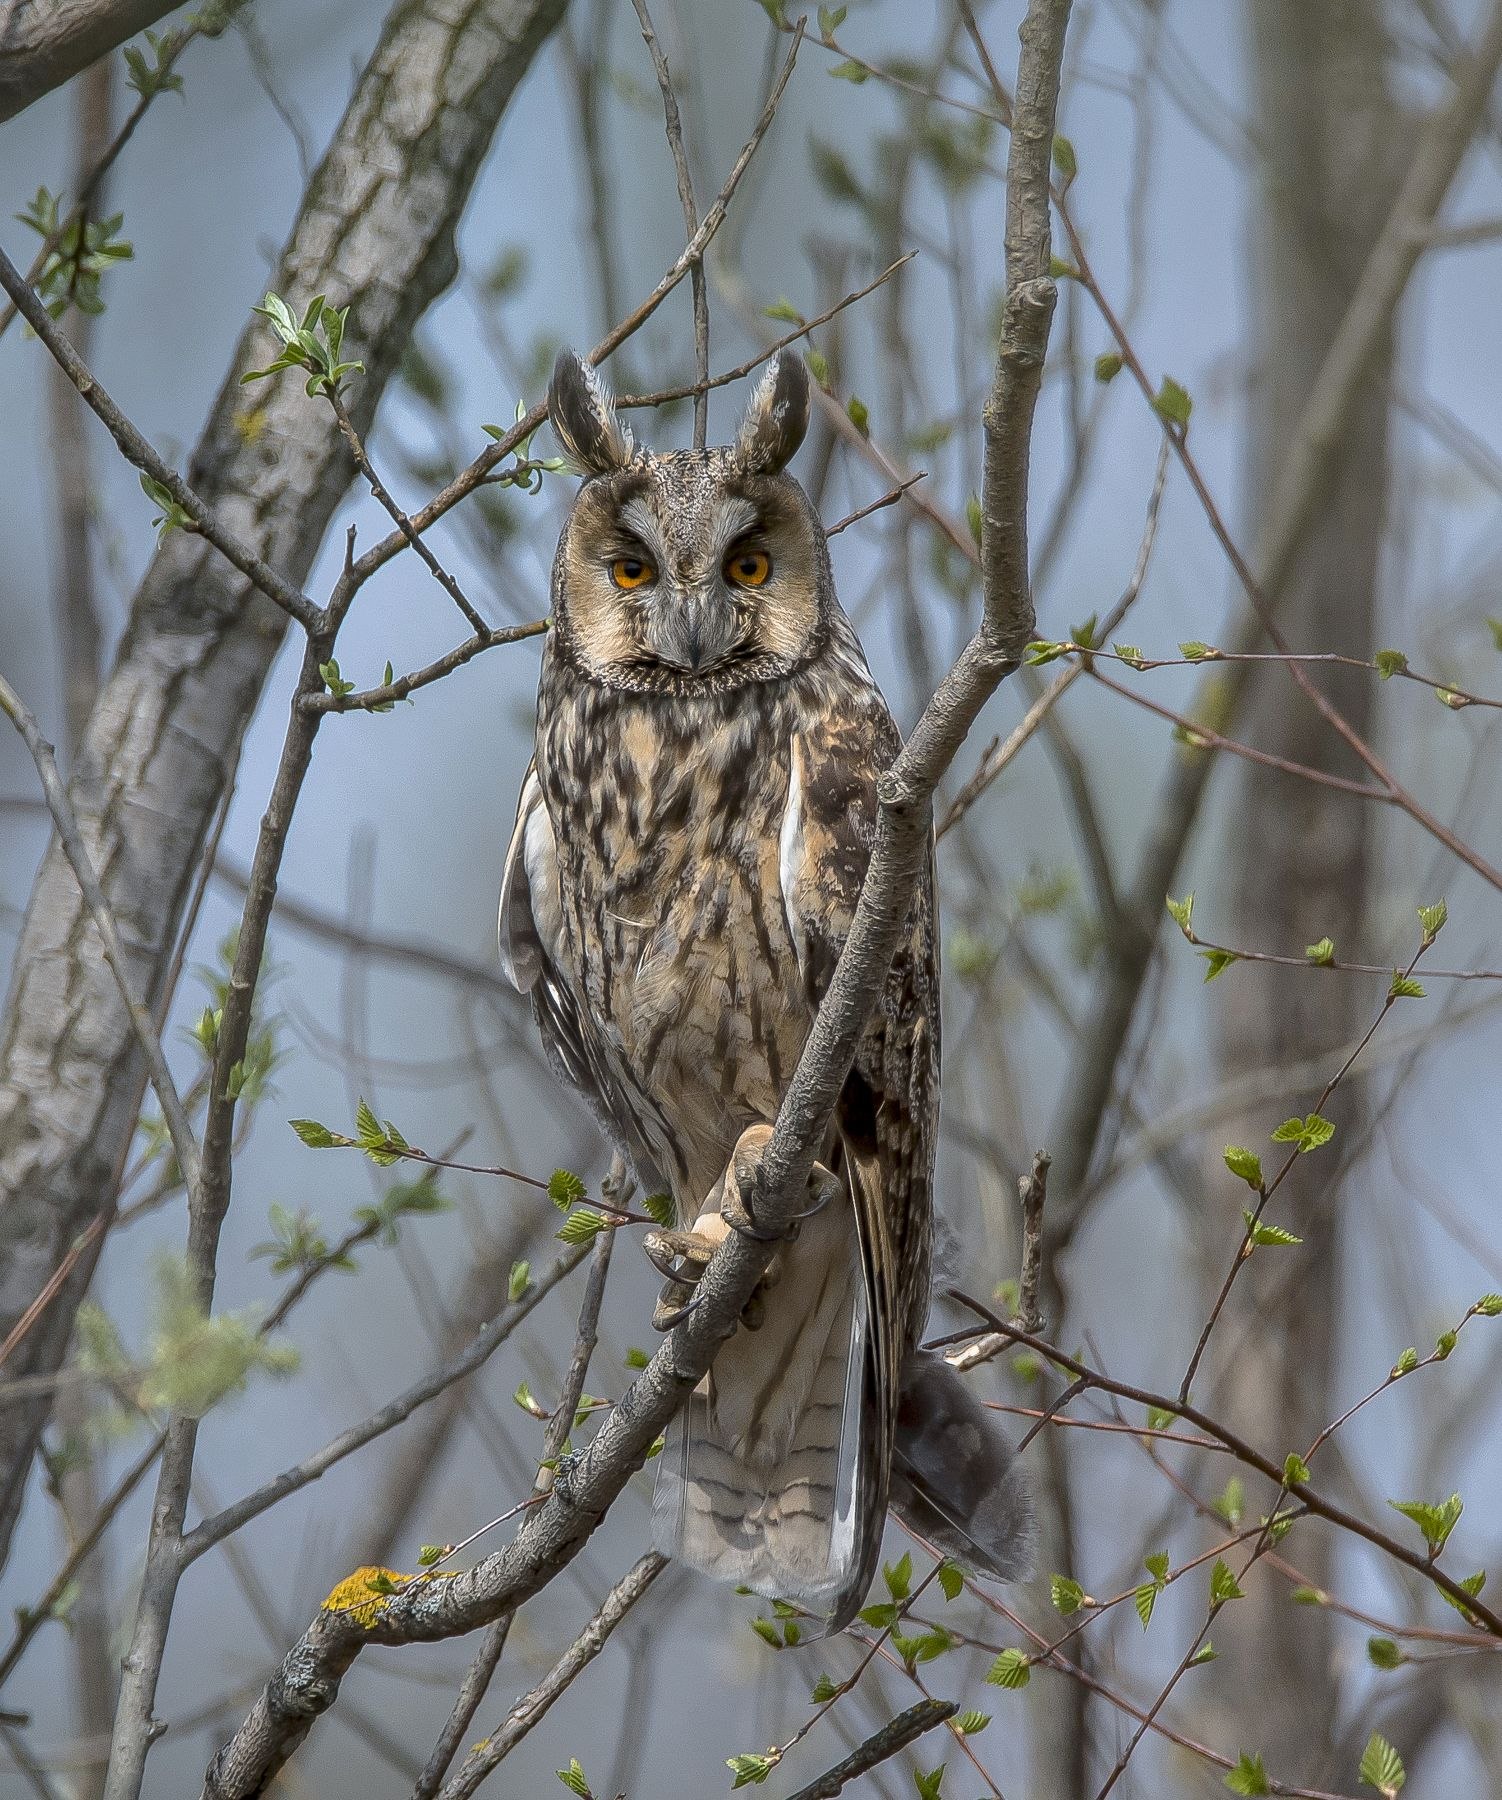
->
[891,1350,1036,1580]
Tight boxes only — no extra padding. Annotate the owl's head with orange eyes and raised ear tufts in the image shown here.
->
[547,351,834,693]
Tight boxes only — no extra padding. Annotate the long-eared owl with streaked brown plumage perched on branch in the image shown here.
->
[501,351,1025,1629]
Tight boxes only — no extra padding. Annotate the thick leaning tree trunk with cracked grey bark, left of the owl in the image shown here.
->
[0,0,566,1561]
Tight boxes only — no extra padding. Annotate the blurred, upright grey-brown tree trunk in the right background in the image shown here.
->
[1201,0,1398,1784]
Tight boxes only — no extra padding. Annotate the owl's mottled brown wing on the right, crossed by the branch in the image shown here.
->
[780,688,938,1627]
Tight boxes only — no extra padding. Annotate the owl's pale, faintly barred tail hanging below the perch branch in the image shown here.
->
[652,1246,884,1636]
